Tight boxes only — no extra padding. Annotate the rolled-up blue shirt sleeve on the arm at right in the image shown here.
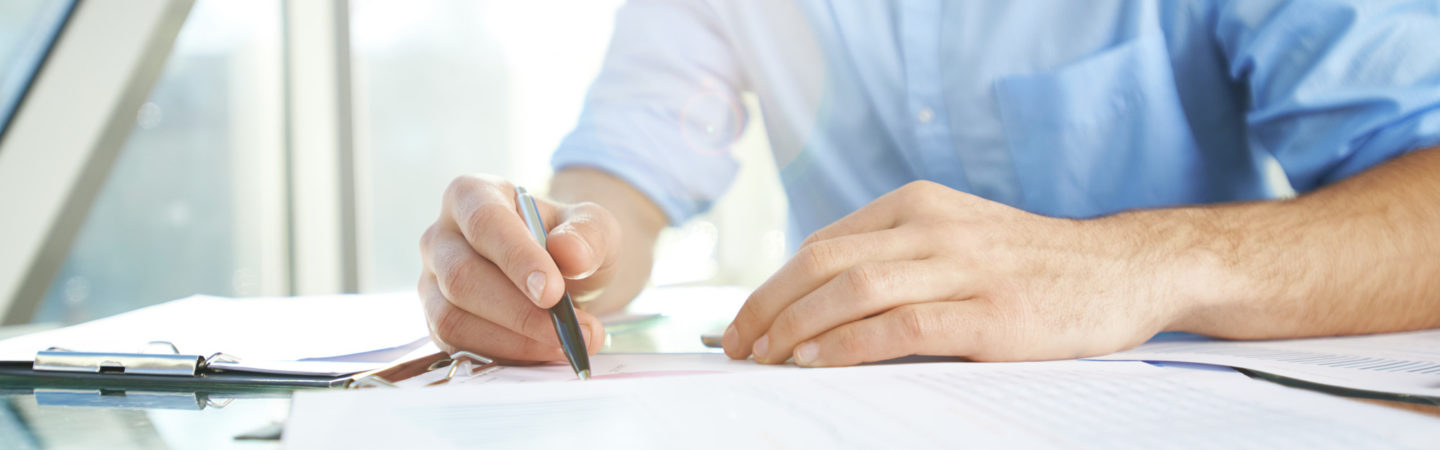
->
[1215,0,1440,193]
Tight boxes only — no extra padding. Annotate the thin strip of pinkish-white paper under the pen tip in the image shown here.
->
[397,353,799,387]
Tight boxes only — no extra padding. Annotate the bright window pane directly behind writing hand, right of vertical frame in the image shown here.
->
[350,0,785,291]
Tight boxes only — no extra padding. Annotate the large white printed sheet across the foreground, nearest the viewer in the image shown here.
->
[284,361,1440,449]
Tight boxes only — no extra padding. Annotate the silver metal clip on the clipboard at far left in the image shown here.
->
[32,340,240,376]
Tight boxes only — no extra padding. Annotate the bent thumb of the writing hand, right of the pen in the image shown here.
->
[546,202,621,290]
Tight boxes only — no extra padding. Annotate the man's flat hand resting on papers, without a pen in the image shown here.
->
[723,182,1203,366]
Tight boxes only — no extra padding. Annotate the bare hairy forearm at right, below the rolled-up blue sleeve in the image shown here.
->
[1152,149,1440,339]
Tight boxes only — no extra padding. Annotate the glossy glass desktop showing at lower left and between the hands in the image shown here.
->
[0,301,1440,449]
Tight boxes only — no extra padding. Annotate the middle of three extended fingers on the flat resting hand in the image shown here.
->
[755,260,975,363]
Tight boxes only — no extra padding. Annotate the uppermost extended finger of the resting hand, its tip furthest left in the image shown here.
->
[721,229,933,359]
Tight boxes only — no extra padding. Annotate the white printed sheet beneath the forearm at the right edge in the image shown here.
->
[1092,330,1440,398]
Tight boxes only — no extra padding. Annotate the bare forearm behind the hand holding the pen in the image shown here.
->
[549,169,665,313]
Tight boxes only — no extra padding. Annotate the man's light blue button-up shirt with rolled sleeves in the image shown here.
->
[553,0,1440,242]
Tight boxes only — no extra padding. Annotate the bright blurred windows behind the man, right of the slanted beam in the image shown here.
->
[0,0,786,323]
